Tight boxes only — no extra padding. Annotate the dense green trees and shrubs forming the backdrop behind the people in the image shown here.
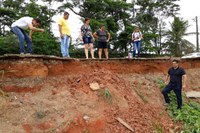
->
[0,0,194,58]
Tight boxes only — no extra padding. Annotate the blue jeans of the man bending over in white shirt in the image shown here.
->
[11,26,32,53]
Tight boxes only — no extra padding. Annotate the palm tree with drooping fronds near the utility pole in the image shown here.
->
[165,17,194,57]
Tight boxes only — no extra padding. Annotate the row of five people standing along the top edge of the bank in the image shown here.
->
[11,12,142,59]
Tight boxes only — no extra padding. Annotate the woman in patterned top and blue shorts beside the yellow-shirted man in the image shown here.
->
[80,18,95,59]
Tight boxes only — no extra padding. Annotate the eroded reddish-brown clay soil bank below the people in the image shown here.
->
[0,59,200,133]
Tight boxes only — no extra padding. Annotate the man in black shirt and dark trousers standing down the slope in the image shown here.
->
[162,60,186,109]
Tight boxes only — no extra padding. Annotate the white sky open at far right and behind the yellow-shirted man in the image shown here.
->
[52,0,200,46]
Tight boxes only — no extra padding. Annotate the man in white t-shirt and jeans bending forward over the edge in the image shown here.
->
[11,17,44,54]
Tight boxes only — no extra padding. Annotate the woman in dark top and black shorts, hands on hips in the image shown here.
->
[93,25,110,59]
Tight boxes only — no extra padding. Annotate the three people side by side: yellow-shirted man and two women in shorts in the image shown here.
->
[58,12,110,59]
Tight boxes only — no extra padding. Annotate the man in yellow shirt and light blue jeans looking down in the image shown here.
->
[58,12,72,58]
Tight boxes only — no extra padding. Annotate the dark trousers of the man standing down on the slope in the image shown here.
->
[162,83,182,109]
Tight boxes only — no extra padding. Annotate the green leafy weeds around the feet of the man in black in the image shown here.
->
[157,81,200,133]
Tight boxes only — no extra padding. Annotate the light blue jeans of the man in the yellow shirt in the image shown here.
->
[60,35,70,57]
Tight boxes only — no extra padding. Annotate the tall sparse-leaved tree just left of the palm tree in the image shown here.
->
[133,0,180,54]
